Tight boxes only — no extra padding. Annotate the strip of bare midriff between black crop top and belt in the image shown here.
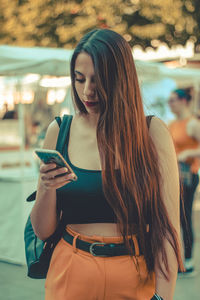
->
[68,223,121,236]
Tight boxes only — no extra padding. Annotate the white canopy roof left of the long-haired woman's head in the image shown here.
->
[0,45,73,76]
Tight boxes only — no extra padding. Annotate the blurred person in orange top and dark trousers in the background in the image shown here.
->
[169,89,200,276]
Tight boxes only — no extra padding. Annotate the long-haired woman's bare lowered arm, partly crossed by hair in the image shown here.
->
[150,118,180,300]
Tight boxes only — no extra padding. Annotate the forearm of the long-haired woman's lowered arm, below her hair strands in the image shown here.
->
[155,241,178,300]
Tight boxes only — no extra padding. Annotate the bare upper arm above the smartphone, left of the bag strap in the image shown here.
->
[43,120,59,149]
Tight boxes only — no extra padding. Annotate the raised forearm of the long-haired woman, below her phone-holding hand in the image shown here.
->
[31,183,58,240]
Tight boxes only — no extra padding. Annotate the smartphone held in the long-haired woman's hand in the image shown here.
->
[35,149,78,181]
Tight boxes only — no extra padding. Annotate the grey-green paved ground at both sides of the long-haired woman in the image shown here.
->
[0,198,200,300]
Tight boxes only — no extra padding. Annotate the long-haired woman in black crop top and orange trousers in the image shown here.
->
[31,29,182,300]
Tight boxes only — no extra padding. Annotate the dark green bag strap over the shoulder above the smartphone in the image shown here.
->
[56,115,73,154]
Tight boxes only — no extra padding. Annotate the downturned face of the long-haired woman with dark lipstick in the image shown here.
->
[74,52,99,113]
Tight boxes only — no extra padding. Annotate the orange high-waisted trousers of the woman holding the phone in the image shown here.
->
[45,227,155,300]
